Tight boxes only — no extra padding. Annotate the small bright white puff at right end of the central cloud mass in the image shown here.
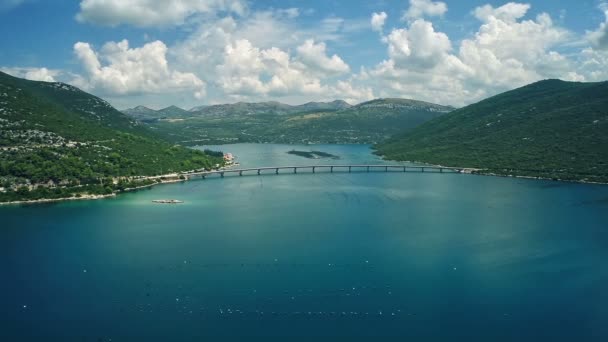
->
[297,39,350,76]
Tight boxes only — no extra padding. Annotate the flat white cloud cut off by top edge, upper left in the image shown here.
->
[76,0,247,27]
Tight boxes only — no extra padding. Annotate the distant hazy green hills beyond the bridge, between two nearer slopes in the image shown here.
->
[129,99,453,145]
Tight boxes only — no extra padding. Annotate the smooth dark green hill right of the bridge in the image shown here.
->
[376,80,608,182]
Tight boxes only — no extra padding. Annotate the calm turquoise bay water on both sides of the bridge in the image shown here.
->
[0,144,608,341]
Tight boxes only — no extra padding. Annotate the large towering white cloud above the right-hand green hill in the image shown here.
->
[368,3,584,105]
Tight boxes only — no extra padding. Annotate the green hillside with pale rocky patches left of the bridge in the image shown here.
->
[0,73,221,201]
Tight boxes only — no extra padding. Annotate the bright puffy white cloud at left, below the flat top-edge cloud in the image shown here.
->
[74,40,205,97]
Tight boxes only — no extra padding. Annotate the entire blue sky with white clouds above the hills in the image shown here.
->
[0,0,608,109]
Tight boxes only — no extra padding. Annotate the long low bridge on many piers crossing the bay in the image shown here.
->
[182,164,475,178]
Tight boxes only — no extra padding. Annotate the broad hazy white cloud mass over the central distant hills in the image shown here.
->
[170,10,369,101]
